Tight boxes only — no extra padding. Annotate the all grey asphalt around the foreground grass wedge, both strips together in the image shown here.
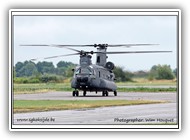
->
[13,92,178,125]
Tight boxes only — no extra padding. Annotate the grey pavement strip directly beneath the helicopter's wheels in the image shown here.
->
[14,92,177,102]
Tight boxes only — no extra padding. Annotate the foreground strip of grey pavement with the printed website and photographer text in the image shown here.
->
[14,103,177,125]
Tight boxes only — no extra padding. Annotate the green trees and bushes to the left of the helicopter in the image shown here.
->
[13,61,76,83]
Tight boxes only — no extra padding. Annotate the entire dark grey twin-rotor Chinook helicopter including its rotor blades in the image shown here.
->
[21,44,171,96]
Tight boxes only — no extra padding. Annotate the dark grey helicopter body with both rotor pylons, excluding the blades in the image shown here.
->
[71,46,117,96]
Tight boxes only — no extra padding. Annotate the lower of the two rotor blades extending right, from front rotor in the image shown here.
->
[104,51,172,54]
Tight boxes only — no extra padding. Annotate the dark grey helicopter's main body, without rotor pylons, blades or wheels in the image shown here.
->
[71,65,117,92]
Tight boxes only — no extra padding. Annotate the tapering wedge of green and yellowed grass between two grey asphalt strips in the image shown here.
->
[13,100,165,113]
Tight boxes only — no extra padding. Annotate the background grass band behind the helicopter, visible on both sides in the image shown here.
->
[13,79,177,94]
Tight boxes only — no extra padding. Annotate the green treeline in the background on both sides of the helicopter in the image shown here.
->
[13,61,177,83]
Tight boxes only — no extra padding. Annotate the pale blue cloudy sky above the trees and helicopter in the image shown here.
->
[13,15,177,71]
